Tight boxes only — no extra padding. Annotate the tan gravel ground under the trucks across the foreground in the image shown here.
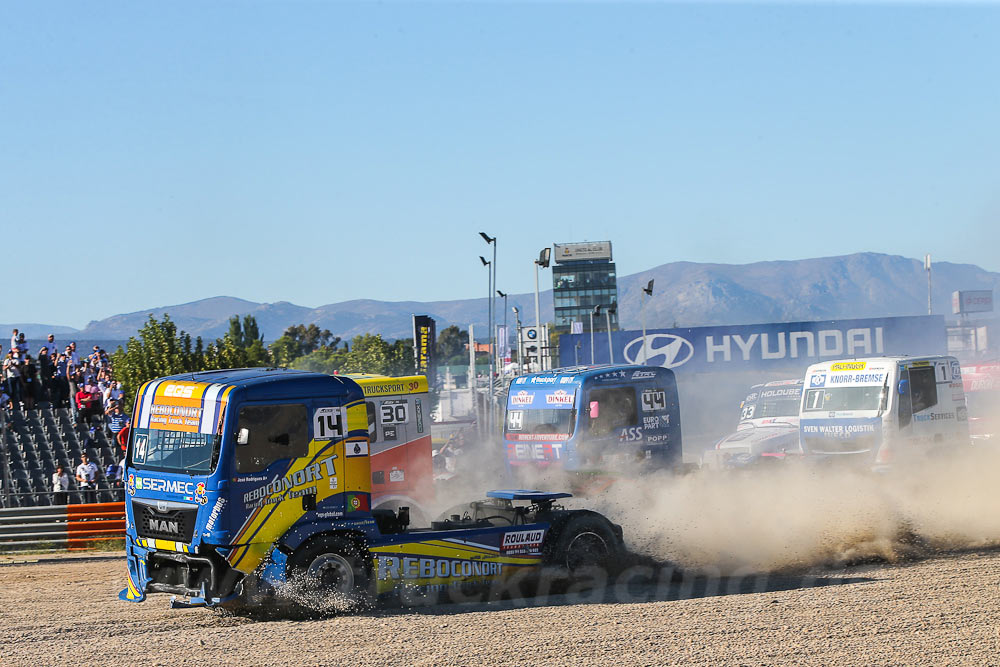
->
[0,550,1000,666]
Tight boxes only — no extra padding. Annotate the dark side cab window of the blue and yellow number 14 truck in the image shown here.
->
[236,404,309,473]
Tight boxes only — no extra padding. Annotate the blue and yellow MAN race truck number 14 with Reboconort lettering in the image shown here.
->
[119,368,624,607]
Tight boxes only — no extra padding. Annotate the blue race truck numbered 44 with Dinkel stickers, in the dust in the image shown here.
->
[503,365,682,474]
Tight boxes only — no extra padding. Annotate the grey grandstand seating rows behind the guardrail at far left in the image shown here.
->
[0,407,122,507]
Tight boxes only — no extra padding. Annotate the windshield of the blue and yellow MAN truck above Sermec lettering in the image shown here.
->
[131,428,221,473]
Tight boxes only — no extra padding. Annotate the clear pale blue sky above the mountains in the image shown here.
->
[0,2,1000,326]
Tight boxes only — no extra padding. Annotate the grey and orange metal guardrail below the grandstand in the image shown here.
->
[0,502,125,553]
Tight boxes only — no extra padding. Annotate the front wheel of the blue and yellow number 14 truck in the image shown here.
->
[288,535,370,611]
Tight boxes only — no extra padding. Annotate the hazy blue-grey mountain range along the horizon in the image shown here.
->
[9,252,1000,340]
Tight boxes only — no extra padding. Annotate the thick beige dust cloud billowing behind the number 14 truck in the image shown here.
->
[587,445,1000,574]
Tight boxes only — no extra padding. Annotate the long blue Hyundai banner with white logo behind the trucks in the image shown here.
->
[559,315,947,373]
